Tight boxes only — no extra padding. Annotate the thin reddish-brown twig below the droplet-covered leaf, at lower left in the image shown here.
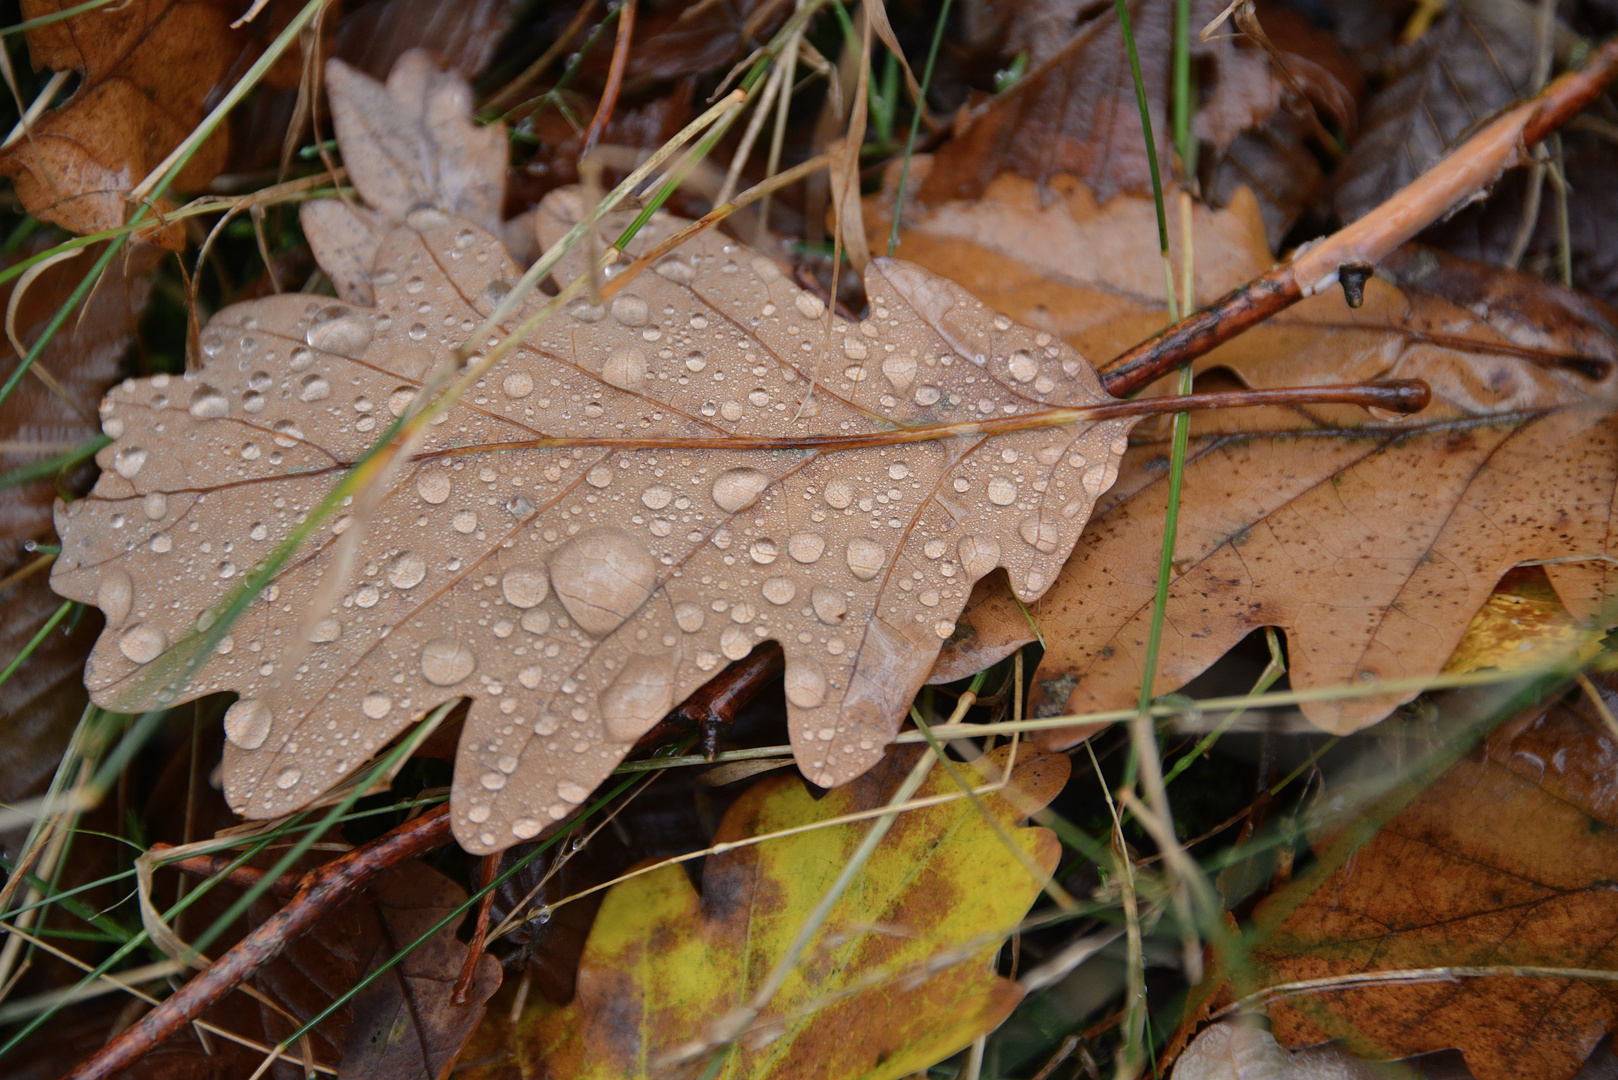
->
[65,803,450,1080]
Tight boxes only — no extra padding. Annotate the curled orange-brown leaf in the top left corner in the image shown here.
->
[0,0,297,241]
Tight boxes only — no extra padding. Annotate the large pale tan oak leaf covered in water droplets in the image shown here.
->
[52,59,1133,852]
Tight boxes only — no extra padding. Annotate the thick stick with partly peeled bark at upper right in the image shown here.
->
[1102,39,1618,397]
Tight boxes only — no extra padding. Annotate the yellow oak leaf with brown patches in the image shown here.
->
[466,746,1068,1080]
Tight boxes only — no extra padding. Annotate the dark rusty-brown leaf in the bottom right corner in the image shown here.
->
[1252,691,1618,1080]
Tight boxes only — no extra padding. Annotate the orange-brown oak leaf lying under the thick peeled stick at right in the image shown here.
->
[904,181,1618,732]
